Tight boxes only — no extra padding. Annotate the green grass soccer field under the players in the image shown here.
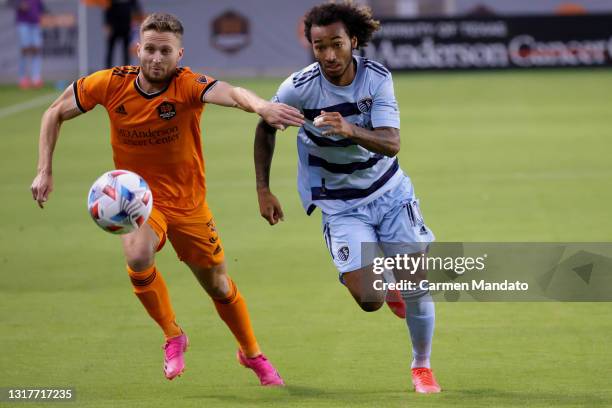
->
[0,70,612,407]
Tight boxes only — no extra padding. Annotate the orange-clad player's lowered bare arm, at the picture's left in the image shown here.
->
[30,85,82,208]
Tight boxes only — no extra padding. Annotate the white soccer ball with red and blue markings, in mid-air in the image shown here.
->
[87,170,153,234]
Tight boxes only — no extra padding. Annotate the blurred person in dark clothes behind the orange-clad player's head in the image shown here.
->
[104,0,142,68]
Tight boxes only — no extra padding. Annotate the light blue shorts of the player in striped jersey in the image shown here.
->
[322,176,435,275]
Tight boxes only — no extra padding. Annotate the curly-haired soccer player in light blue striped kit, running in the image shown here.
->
[255,2,441,393]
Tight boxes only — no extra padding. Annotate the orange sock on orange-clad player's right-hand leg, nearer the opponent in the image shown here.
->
[213,277,261,358]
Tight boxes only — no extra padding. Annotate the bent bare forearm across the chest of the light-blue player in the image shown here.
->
[315,115,400,157]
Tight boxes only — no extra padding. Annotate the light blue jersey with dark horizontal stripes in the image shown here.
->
[274,56,403,215]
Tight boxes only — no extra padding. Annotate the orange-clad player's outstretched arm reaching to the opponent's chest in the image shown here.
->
[203,81,304,130]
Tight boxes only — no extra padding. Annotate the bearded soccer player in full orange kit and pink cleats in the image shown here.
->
[31,13,303,385]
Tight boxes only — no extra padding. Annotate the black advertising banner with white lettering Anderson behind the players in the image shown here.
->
[363,14,612,70]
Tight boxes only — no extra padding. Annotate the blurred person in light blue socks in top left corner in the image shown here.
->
[9,0,45,89]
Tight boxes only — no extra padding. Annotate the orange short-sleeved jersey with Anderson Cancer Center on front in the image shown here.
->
[73,66,216,212]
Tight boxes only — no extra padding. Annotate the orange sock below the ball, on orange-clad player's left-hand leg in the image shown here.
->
[127,265,182,338]
